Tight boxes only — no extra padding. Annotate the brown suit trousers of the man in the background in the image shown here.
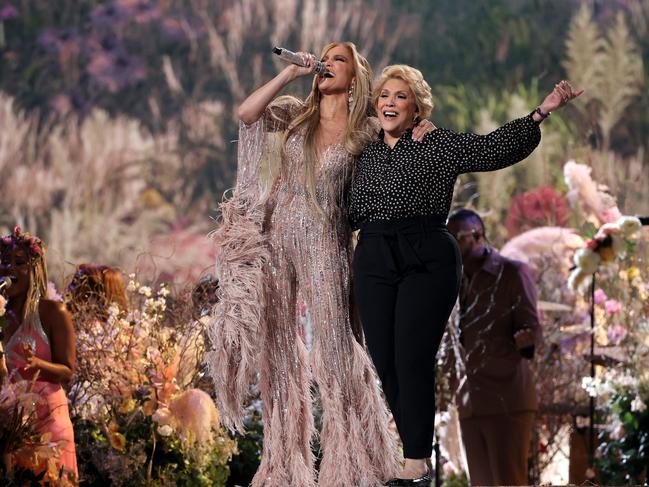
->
[460,412,535,486]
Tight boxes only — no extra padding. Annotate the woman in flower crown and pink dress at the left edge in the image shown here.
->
[0,227,78,482]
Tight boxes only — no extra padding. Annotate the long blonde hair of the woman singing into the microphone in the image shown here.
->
[265,42,373,215]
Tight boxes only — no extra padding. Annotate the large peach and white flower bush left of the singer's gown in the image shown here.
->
[69,275,237,486]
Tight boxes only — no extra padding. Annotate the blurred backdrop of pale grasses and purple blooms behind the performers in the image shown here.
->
[0,0,649,284]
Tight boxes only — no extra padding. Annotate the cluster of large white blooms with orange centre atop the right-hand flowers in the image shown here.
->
[568,216,641,291]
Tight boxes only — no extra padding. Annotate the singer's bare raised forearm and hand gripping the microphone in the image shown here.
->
[237,53,315,125]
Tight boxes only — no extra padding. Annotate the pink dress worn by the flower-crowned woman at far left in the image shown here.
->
[5,313,79,479]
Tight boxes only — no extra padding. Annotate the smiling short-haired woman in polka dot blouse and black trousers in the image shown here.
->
[350,65,580,486]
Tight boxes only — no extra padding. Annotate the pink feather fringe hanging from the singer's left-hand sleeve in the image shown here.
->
[205,195,269,432]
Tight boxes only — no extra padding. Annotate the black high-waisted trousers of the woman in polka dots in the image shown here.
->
[353,215,462,458]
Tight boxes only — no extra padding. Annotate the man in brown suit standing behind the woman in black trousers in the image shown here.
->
[448,209,541,485]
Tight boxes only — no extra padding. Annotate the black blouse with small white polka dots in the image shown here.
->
[349,114,541,228]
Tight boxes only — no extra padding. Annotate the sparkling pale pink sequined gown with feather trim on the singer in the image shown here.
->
[208,100,397,487]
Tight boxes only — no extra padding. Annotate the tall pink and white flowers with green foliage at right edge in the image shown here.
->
[581,246,649,485]
